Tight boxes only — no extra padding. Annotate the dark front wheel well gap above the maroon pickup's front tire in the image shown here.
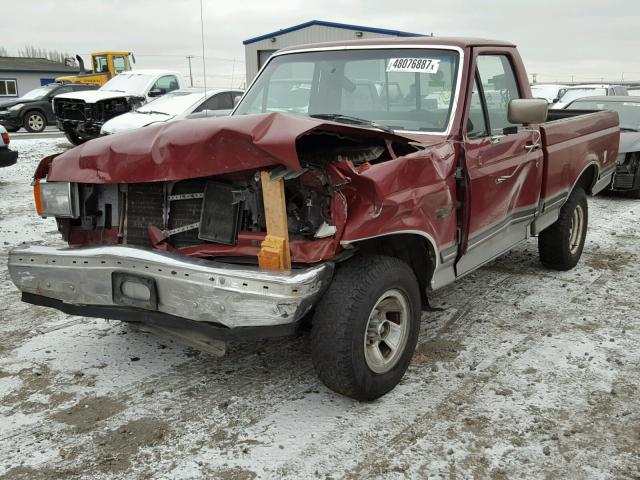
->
[341,231,439,306]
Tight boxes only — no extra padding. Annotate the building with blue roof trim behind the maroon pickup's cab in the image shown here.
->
[242,20,424,85]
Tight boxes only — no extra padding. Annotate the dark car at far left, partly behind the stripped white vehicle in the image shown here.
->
[0,83,98,132]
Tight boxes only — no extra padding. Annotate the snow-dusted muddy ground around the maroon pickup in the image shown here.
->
[0,139,640,480]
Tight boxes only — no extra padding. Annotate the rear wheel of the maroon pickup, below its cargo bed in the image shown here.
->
[538,186,589,271]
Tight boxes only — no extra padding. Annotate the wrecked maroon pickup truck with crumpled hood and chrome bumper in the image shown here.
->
[9,38,619,399]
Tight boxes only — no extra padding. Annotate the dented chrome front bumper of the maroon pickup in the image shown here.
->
[8,245,333,328]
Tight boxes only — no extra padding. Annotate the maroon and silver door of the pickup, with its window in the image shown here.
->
[456,52,543,275]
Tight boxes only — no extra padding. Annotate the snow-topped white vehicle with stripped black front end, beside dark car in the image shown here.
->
[53,70,186,145]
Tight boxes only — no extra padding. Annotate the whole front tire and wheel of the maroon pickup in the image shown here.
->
[311,255,421,400]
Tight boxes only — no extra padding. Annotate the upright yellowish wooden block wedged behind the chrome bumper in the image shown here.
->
[258,172,291,270]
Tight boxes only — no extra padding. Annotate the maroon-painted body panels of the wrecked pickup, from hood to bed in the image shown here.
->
[37,39,619,263]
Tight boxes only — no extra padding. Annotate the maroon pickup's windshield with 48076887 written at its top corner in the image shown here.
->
[234,49,458,132]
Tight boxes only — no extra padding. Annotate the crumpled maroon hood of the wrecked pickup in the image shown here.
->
[46,113,416,183]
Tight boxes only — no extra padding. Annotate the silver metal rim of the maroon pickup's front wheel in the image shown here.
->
[364,289,410,374]
